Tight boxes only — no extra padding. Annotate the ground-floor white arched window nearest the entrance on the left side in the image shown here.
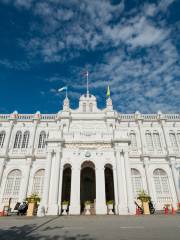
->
[32,169,45,197]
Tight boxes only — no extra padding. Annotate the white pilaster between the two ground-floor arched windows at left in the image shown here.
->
[19,158,32,202]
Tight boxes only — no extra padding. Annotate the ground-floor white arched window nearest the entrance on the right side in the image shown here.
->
[131,168,143,198]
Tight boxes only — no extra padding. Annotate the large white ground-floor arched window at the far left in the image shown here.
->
[3,169,22,204]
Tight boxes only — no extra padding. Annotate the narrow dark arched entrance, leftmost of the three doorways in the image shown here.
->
[61,164,71,209]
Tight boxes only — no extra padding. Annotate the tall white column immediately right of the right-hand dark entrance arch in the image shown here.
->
[116,149,128,215]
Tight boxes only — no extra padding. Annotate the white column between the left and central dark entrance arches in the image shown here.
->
[69,165,80,215]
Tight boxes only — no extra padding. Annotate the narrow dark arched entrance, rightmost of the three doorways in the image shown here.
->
[104,164,115,211]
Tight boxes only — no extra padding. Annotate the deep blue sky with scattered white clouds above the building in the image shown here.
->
[0,0,180,113]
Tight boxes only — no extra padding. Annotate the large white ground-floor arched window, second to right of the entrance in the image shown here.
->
[153,169,171,202]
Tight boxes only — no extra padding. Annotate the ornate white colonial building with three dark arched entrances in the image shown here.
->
[0,94,180,215]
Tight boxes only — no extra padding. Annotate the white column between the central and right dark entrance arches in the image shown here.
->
[96,164,107,214]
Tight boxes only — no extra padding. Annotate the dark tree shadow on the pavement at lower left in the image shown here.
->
[0,219,95,240]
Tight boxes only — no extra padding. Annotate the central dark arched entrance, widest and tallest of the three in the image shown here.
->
[80,162,96,214]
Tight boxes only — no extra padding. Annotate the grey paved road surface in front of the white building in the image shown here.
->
[0,215,180,240]
